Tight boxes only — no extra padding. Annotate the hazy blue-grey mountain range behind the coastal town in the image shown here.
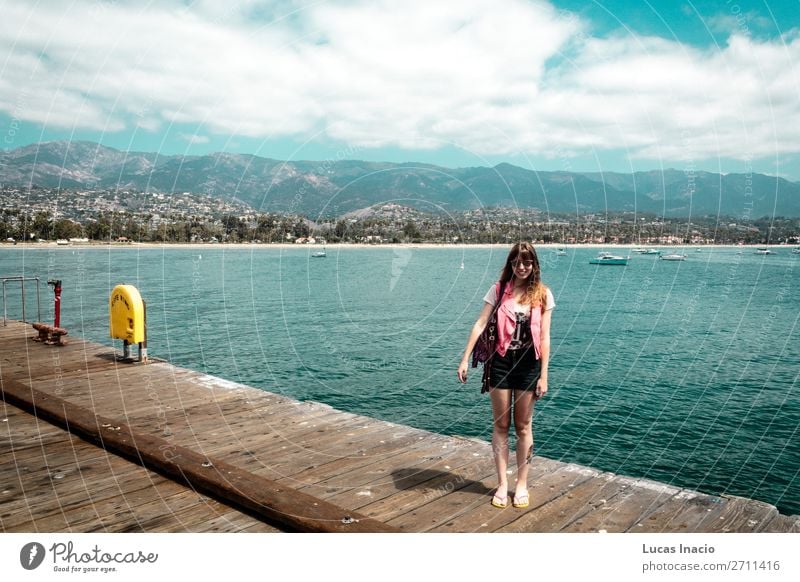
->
[0,141,800,219]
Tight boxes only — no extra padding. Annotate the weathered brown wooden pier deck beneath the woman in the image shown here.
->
[0,322,800,533]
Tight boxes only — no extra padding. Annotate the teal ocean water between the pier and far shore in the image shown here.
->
[0,246,800,514]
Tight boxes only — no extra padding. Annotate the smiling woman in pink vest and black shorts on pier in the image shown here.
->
[458,242,555,508]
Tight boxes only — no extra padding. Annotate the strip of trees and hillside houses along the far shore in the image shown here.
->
[0,209,800,244]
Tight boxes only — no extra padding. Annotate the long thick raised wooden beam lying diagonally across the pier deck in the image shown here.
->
[3,380,394,532]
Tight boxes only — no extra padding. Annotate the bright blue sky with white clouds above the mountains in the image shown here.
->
[0,0,800,181]
